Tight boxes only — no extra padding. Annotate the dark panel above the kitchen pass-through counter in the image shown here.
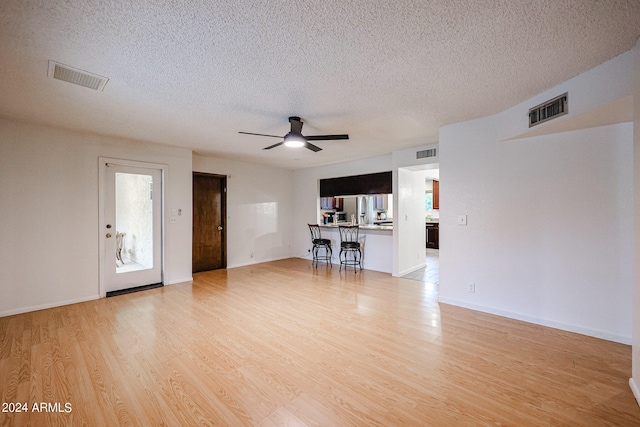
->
[320,171,392,197]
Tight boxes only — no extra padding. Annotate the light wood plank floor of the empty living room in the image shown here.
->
[0,259,640,426]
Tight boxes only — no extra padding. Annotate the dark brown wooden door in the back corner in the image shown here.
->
[192,173,227,273]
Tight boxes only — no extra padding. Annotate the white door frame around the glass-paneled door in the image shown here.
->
[98,157,169,298]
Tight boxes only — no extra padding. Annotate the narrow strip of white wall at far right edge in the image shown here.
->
[629,39,640,403]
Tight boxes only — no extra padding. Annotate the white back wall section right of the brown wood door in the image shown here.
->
[193,155,300,268]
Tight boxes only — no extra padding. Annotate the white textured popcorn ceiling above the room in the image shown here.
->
[0,0,640,168]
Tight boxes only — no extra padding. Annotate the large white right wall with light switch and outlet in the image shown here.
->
[440,53,633,343]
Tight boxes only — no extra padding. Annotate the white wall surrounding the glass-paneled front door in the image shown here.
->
[0,119,191,316]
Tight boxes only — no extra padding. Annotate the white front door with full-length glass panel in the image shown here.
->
[102,163,162,292]
